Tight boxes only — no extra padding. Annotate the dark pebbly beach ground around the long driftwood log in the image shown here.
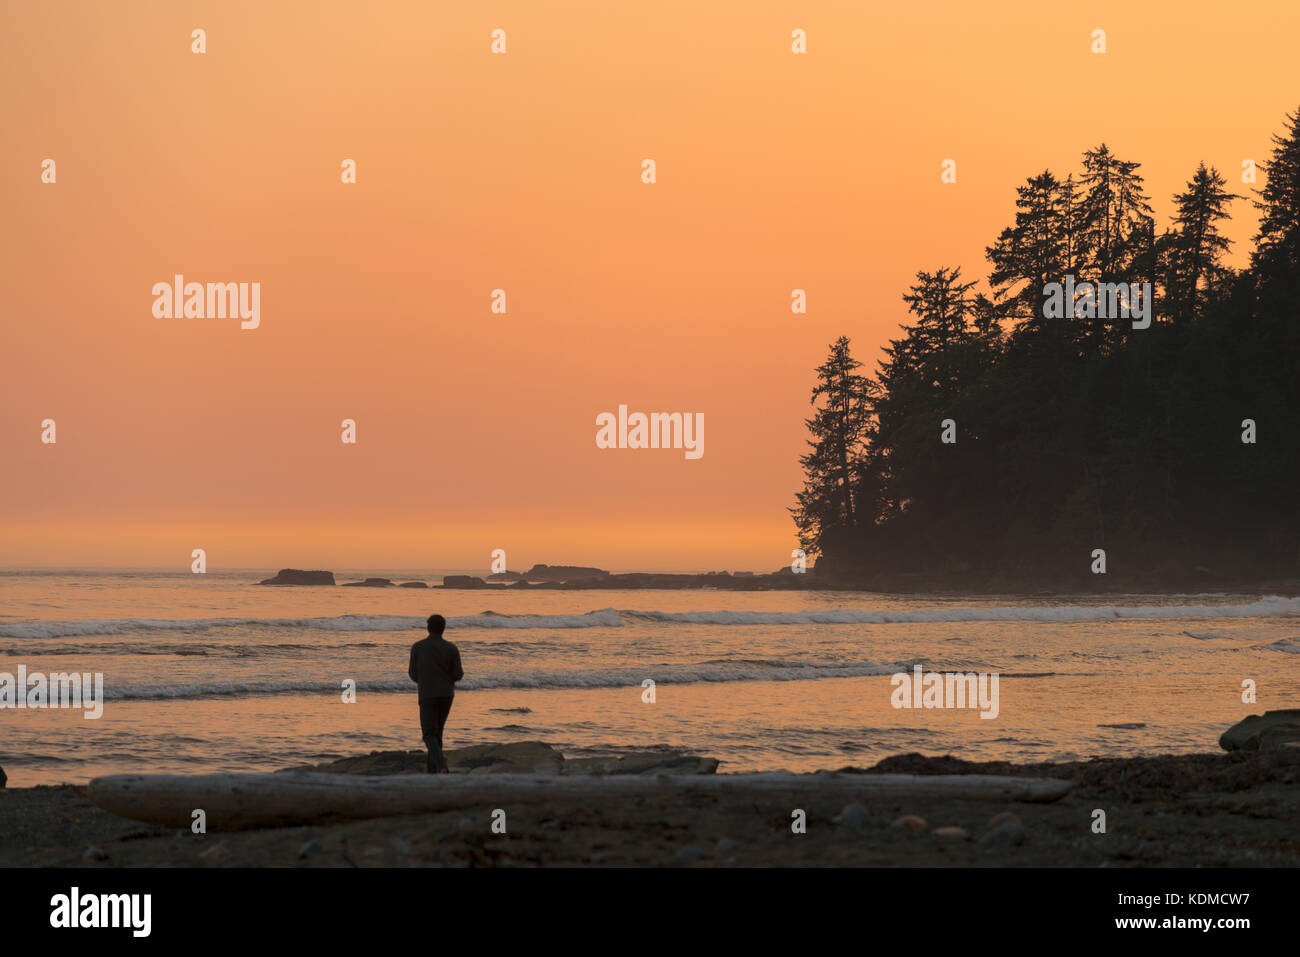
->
[0,744,1300,867]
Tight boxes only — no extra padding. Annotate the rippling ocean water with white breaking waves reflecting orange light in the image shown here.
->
[0,570,1300,787]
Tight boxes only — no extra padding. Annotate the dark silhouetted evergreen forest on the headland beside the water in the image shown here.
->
[790,111,1300,589]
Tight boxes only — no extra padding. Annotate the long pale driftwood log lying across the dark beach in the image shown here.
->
[87,771,1070,831]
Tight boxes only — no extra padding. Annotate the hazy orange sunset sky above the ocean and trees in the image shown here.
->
[0,0,1300,571]
